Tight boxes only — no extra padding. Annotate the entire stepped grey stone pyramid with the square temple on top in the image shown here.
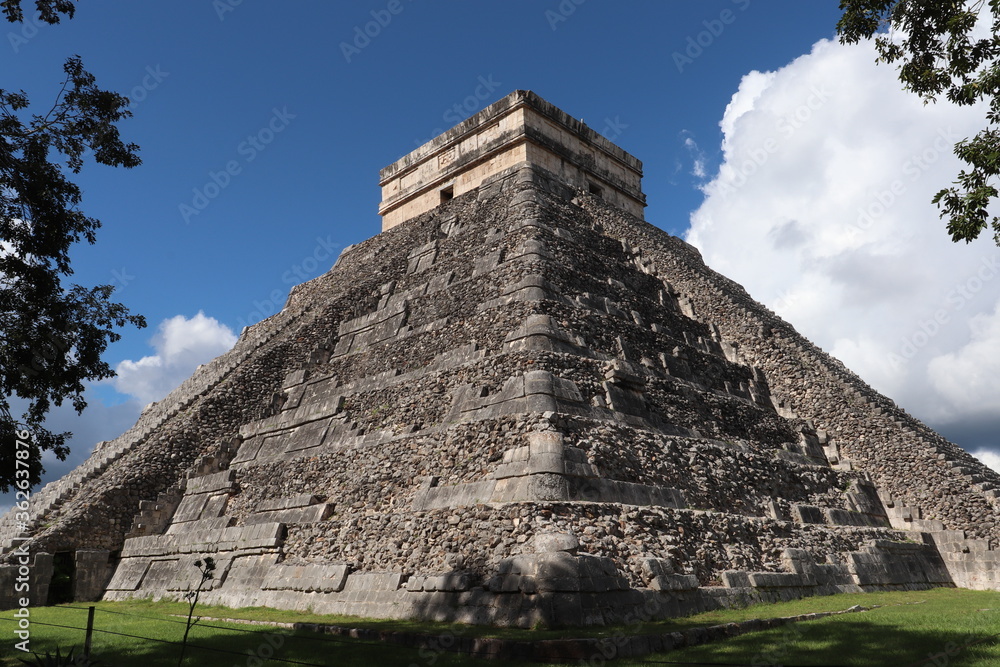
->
[0,91,1000,627]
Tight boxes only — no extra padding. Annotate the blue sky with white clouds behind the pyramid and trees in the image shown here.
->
[0,0,1000,500]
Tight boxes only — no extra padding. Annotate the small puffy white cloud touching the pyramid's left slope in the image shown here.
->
[113,311,237,403]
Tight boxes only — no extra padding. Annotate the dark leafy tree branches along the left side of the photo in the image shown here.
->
[0,9,146,491]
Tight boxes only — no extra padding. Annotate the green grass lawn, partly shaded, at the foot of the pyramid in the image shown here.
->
[0,589,1000,667]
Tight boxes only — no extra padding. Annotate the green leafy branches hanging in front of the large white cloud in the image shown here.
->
[837,0,1000,245]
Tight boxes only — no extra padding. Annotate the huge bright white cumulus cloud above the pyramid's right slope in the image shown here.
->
[687,35,1000,444]
